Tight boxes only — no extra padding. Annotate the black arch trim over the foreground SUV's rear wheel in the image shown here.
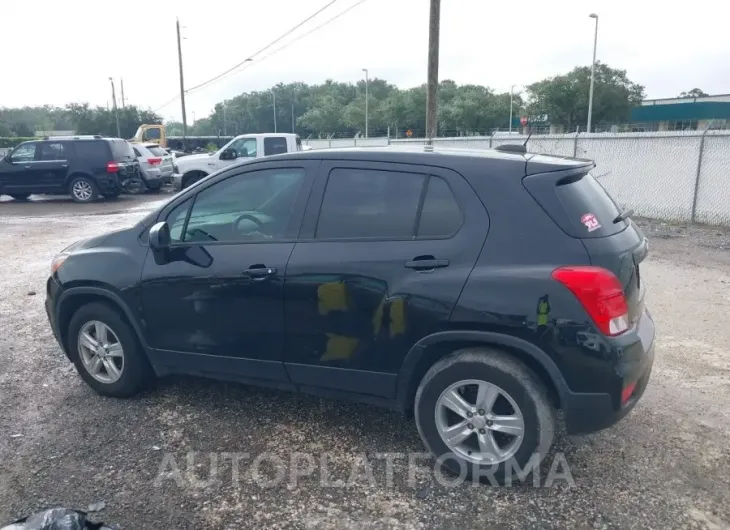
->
[396,330,570,414]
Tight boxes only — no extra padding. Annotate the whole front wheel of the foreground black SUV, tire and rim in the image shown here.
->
[68,303,152,397]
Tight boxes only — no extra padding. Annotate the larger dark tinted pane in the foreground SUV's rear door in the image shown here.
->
[316,169,426,239]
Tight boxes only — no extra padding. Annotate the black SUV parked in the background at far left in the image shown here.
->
[0,136,139,202]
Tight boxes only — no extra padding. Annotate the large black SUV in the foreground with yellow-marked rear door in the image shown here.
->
[46,148,654,479]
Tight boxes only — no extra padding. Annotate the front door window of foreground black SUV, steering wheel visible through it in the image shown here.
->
[184,168,305,242]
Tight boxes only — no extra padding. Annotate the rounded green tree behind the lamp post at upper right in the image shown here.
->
[527,62,644,129]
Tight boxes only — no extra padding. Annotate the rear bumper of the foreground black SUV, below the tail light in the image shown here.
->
[562,311,655,434]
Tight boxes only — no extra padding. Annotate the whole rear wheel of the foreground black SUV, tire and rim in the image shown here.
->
[415,348,555,483]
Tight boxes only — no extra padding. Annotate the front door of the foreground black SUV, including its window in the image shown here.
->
[141,161,315,381]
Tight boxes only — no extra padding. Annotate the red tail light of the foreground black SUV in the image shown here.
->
[552,267,629,336]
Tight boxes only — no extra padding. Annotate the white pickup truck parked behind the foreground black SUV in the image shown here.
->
[172,133,303,190]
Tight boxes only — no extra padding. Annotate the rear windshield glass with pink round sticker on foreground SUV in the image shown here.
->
[524,173,629,239]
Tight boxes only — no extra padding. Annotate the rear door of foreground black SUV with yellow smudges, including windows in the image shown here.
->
[284,160,489,398]
